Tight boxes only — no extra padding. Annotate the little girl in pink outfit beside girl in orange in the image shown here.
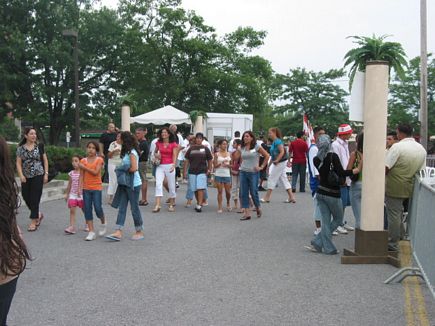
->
[65,155,83,234]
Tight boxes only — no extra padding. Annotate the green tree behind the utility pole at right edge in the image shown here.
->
[388,55,435,135]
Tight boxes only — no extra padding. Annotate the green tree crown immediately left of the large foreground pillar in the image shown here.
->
[273,68,348,135]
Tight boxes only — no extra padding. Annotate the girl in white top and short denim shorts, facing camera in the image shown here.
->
[214,139,231,214]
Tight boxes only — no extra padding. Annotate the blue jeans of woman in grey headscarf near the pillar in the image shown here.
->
[311,194,343,255]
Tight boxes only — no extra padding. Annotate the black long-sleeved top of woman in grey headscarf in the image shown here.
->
[313,153,353,198]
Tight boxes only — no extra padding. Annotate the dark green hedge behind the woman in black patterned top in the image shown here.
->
[9,145,86,173]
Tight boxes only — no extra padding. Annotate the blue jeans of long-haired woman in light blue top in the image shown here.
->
[116,186,143,231]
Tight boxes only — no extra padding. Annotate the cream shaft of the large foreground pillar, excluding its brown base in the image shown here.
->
[361,61,389,231]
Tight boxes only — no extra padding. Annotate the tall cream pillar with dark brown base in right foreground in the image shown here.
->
[341,61,400,267]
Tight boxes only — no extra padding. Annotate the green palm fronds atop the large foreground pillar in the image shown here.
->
[344,35,407,87]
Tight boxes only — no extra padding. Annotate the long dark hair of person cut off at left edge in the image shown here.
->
[0,137,30,276]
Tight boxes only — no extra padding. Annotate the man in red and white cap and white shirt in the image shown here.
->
[332,124,354,235]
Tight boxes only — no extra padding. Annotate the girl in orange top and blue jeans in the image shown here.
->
[79,141,107,241]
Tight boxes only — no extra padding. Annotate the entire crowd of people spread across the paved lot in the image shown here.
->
[0,124,426,324]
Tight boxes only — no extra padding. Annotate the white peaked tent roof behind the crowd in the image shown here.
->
[130,105,192,125]
